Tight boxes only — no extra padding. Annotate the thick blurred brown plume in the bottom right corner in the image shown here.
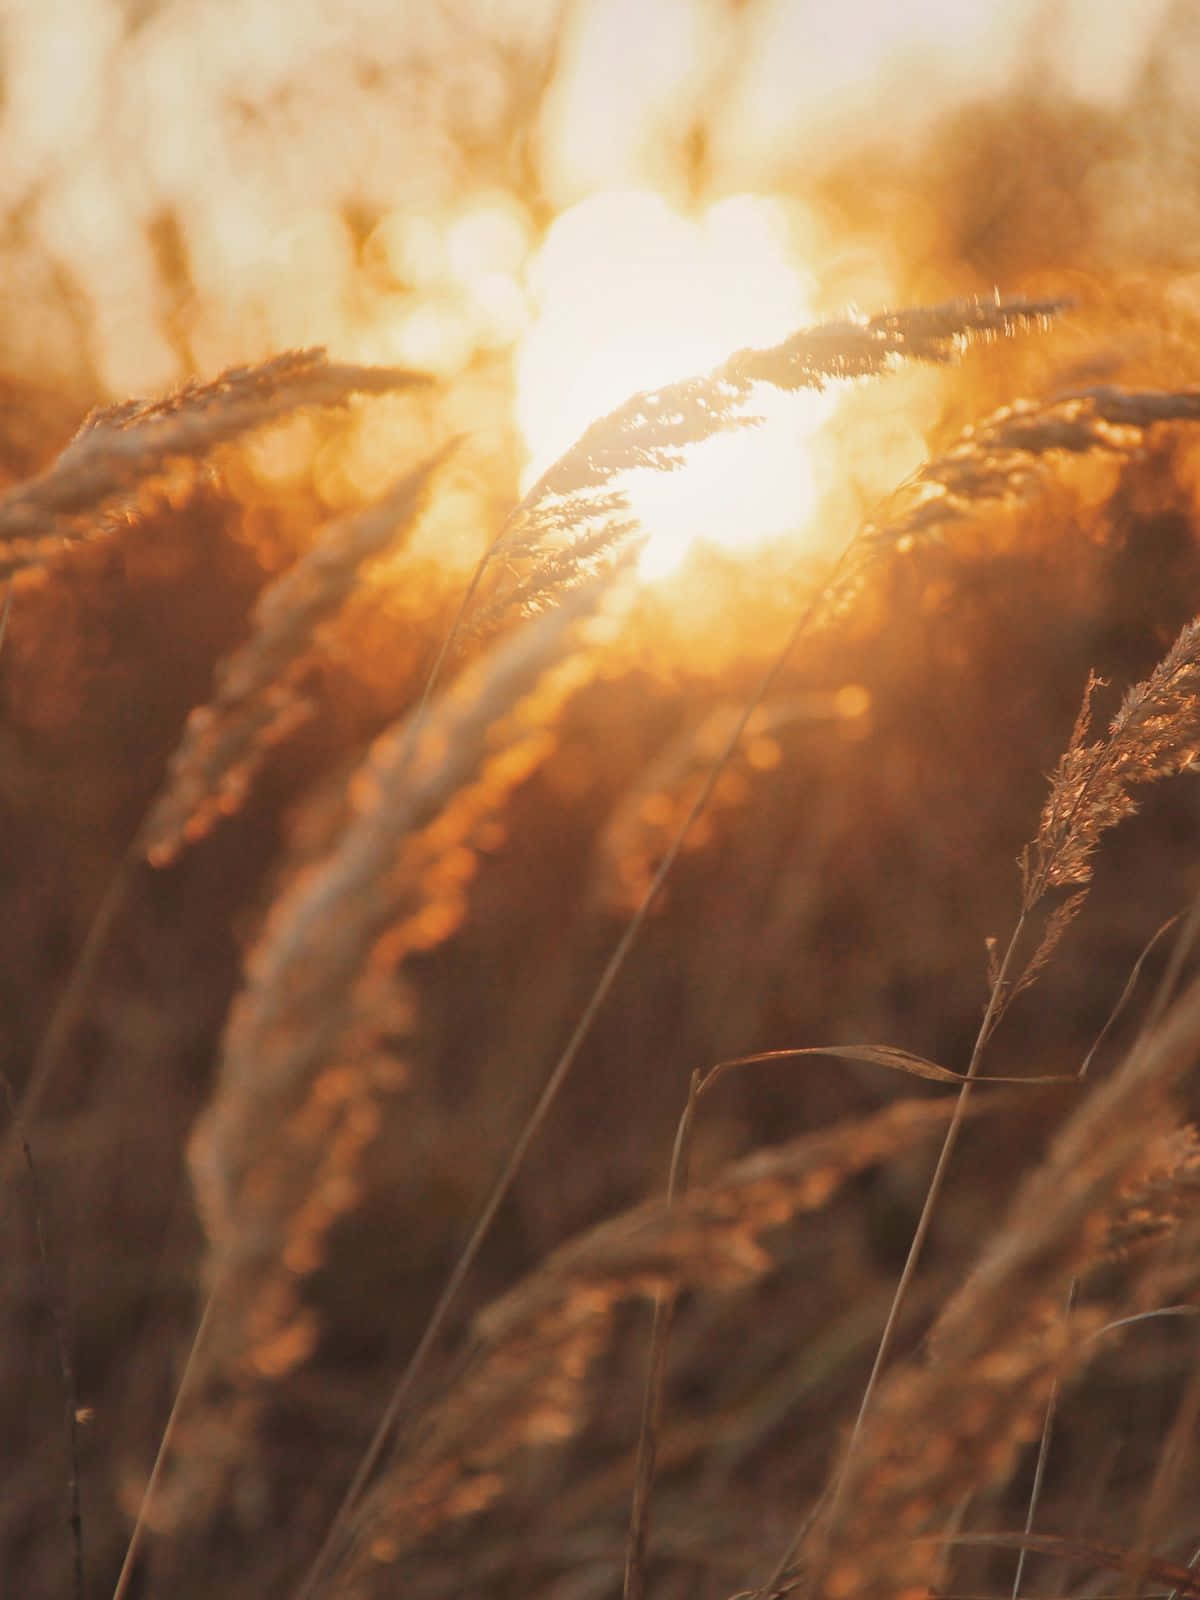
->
[803,984,1200,1600]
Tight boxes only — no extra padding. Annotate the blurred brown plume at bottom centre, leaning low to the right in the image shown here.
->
[328,1101,949,1600]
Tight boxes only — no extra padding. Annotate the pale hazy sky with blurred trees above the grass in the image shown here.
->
[0,0,1200,565]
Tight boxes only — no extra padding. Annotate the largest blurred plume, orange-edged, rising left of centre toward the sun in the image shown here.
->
[158,586,620,1522]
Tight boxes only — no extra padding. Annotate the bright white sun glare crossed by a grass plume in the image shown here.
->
[517,190,834,578]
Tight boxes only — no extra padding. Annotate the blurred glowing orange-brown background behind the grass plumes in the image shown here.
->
[0,0,1200,1600]
